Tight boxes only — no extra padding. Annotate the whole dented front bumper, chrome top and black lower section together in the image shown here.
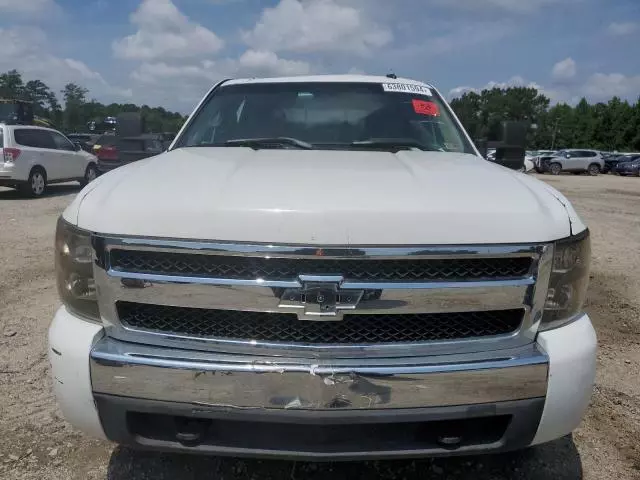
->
[90,337,549,460]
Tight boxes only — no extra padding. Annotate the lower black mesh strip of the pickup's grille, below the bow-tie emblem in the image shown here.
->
[118,302,523,345]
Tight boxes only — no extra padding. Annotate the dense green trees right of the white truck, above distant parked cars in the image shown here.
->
[451,87,640,152]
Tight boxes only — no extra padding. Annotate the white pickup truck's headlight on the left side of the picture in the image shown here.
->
[55,217,100,322]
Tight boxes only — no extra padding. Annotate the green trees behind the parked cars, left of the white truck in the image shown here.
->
[0,70,186,133]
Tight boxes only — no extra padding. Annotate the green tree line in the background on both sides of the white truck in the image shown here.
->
[0,70,640,152]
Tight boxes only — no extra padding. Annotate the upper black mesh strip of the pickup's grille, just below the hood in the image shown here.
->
[110,249,532,282]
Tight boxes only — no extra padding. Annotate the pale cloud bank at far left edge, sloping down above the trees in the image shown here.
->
[0,27,132,101]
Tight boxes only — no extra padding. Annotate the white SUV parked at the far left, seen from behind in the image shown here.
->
[0,125,97,197]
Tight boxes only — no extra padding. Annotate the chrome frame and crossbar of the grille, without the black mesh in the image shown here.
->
[94,236,553,358]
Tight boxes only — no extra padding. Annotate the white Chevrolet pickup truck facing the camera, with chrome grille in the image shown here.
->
[49,76,596,460]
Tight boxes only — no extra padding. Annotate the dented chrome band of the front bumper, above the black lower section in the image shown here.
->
[91,337,548,411]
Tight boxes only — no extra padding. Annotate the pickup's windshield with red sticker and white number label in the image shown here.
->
[176,82,475,154]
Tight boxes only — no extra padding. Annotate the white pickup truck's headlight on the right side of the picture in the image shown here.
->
[540,230,591,330]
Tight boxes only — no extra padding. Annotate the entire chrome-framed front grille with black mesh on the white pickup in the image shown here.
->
[93,236,553,358]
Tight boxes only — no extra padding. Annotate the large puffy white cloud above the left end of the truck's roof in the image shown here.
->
[120,0,316,111]
